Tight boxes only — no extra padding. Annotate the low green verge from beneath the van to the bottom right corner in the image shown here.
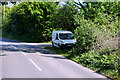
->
[45,46,120,80]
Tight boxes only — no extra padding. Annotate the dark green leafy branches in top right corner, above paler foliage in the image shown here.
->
[75,2,119,22]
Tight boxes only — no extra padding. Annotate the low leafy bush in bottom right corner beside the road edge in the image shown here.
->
[79,48,120,78]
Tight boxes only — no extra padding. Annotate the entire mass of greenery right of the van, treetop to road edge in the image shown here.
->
[45,2,120,79]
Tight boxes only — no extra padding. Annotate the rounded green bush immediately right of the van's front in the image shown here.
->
[74,20,96,54]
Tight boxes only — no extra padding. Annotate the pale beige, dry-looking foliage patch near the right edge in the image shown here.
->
[92,28,118,50]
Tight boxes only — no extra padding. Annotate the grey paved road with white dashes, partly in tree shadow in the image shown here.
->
[0,38,106,79]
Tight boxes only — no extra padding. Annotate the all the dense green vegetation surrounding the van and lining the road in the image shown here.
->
[3,2,120,79]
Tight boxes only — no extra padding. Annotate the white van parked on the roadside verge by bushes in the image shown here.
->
[52,31,76,47]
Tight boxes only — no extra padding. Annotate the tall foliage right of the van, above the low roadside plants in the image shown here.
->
[73,2,119,54]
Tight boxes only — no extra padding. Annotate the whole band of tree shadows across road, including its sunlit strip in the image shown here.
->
[1,38,65,59]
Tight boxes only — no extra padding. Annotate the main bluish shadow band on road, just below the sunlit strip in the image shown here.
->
[2,43,51,54]
